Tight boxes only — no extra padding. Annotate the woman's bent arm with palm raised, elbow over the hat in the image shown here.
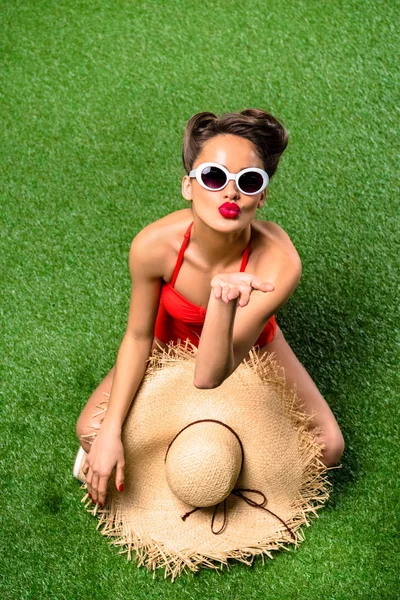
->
[194,245,301,388]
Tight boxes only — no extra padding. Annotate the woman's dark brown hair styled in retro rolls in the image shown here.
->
[182,108,288,177]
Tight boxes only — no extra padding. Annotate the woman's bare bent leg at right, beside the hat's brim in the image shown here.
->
[260,327,344,467]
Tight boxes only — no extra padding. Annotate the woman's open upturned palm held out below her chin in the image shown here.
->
[211,273,275,306]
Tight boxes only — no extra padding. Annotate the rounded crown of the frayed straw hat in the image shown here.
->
[165,420,243,507]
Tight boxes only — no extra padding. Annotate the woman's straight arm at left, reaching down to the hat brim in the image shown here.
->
[85,232,165,503]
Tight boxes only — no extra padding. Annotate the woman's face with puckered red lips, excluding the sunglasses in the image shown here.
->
[182,134,265,232]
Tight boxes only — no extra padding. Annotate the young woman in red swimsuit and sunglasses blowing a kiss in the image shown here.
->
[77,109,344,505]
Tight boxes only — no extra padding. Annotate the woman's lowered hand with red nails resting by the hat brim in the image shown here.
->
[82,428,125,506]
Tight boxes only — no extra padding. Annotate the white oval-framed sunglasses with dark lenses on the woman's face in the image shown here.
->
[189,163,269,196]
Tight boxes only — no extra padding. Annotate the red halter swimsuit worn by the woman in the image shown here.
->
[154,223,276,346]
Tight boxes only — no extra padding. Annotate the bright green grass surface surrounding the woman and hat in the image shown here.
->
[0,0,400,600]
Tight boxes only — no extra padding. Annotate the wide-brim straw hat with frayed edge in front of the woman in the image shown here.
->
[82,344,330,579]
